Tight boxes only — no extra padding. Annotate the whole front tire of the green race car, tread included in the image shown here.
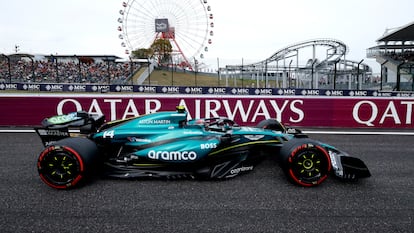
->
[280,138,331,187]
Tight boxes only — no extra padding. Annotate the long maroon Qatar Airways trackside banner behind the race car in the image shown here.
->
[0,94,414,128]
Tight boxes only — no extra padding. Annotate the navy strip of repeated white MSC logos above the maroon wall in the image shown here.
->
[0,83,414,97]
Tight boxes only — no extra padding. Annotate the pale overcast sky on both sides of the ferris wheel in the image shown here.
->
[0,0,414,72]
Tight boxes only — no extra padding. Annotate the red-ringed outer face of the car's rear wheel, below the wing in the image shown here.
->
[38,147,83,188]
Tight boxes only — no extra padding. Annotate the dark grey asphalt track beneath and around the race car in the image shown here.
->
[0,130,414,233]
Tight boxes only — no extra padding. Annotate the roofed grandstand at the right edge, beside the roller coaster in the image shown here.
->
[367,22,414,91]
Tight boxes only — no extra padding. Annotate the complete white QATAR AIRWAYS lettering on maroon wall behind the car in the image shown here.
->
[52,99,305,124]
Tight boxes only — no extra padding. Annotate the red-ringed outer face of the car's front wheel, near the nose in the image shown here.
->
[289,147,330,186]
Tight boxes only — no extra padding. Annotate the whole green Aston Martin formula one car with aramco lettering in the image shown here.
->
[36,106,370,189]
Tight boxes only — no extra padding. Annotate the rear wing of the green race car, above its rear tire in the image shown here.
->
[35,111,105,146]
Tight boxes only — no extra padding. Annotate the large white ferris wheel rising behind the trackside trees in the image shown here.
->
[118,0,214,69]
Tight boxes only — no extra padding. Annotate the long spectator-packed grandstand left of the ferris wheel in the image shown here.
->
[0,53,140,84]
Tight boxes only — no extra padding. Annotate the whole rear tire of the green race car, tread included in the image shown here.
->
[37,138,98,189]
